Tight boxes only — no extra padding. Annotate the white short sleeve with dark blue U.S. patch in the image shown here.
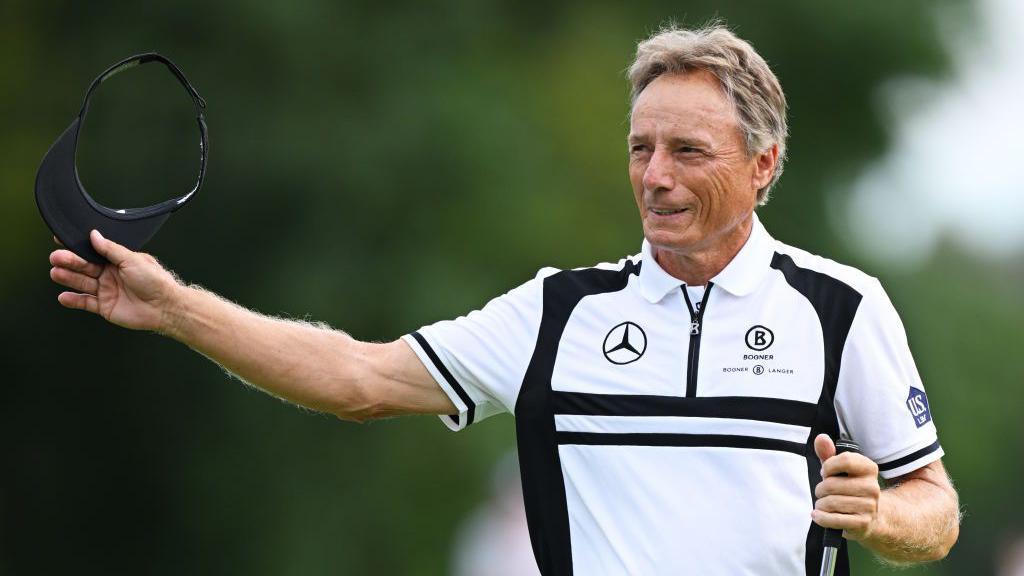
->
[836,280,943,479]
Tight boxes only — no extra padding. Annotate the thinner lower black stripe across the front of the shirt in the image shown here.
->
[555,431,807,456]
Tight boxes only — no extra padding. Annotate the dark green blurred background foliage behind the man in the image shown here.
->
[0,0,1024,575]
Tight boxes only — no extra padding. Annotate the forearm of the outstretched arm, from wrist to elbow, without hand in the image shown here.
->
[160,286,374,420]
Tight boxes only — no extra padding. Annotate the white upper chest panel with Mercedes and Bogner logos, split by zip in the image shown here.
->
[551,278,824,403]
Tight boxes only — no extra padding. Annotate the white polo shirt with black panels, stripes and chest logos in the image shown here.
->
[404,215,943,576]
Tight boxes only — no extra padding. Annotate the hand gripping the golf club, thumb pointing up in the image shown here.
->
[811,434,882,540]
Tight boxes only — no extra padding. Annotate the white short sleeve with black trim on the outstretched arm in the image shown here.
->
[402,269,555,430]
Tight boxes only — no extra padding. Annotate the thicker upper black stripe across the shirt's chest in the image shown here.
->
[551,392,817,426]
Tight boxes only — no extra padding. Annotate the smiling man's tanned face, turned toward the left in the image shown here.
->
[629,71,775,254]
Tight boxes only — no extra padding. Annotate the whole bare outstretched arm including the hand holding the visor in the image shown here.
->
[50,232,458,421]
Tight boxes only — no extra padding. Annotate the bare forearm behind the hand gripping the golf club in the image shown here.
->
[860,470,959,564]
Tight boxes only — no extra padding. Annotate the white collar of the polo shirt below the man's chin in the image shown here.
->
[638,212,775,303]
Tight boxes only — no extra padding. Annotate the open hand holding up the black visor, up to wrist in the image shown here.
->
[50,230,181,331]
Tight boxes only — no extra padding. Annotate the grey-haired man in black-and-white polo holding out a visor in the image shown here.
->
[50,27,958,576]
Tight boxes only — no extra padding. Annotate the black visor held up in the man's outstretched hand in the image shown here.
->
[36,52,209,263]
